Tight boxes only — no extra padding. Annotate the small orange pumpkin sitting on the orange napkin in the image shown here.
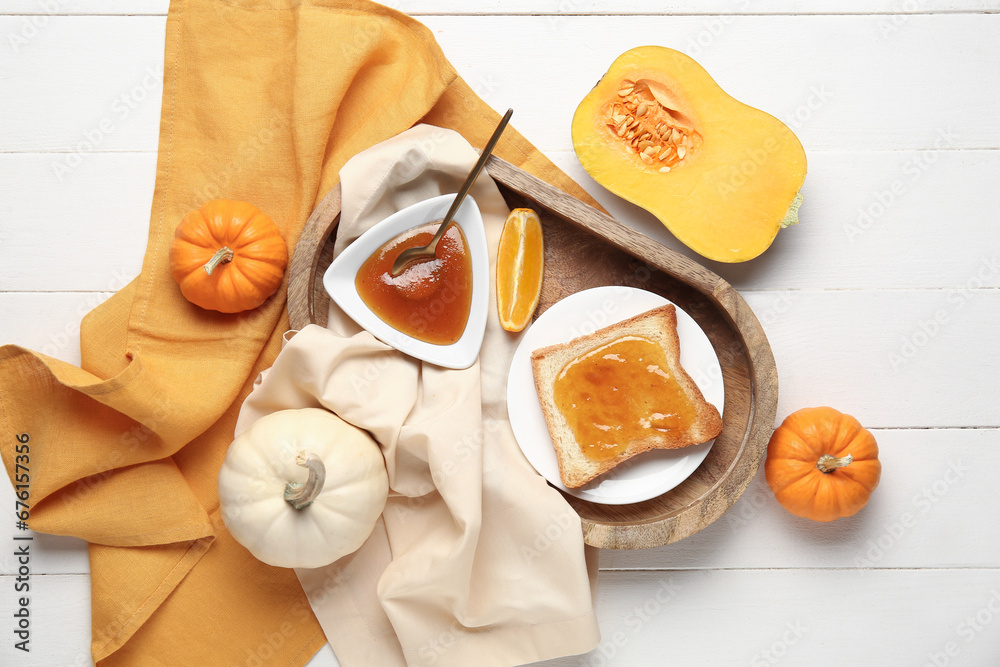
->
[170,199,288,313]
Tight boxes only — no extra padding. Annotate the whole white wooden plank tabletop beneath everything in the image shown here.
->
[0,0,1000,667]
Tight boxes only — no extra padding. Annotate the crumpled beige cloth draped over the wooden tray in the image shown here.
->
[236,125,599,667]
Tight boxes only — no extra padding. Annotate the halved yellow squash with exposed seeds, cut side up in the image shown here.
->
[573,46,806,262]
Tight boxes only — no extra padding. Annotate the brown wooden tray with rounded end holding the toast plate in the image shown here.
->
[288,156,778,549]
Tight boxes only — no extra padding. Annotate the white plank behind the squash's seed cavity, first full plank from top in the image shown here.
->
[0,14,1000,153]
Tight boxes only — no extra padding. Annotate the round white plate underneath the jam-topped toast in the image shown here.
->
[507,286,725,505]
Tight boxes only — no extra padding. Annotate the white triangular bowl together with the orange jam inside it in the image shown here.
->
[323,194,489,368]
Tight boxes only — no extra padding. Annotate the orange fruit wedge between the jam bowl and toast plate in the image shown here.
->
[497,208,545,332]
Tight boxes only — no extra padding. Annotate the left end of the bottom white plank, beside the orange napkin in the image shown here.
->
[0,574,93,667]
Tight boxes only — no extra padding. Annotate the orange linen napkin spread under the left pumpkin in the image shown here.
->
[0,0,600,665]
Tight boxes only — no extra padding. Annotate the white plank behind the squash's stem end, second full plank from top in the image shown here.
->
[0,151,1000,291]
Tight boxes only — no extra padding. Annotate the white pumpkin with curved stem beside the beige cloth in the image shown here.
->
[219,408,389,568]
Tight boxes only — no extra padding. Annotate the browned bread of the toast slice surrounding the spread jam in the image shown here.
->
[531,304,722,488]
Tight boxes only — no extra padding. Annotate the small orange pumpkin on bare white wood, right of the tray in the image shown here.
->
[764,407,882,521]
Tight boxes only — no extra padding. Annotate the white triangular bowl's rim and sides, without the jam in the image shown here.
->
[323,194,490,368]
